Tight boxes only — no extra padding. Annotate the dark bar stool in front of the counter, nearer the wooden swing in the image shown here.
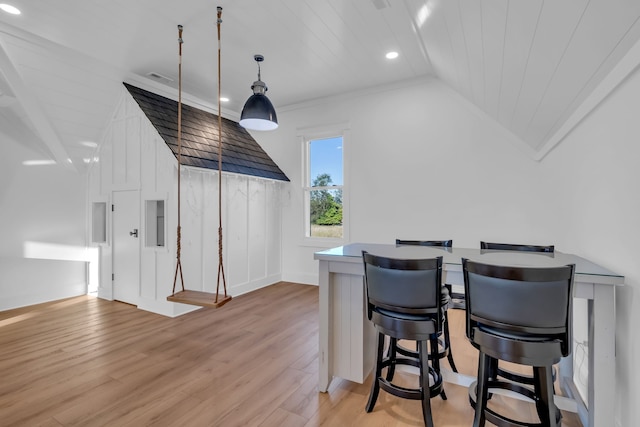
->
[362,251,442,427]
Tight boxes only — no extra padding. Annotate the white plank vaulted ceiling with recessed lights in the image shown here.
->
[0,0,640,170]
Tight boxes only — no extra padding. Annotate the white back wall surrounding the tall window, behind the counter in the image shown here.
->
[256,80,561,283]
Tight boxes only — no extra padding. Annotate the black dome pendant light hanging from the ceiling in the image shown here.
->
[240,55,278,130]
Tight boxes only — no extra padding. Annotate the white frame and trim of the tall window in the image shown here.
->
[298,124,349,248]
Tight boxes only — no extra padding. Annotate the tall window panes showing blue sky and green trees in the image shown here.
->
[304,135,345,239]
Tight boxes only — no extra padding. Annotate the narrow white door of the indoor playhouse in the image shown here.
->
[112,191,140,305]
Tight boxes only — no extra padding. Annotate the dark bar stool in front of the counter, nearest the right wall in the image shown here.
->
[462,258,575,427]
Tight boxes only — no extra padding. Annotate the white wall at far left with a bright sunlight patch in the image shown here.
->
[0,137,87,310]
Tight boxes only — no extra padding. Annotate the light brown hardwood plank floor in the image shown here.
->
[0,282,580,427]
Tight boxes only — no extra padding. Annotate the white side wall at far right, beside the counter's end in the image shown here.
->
[541,64,640,426]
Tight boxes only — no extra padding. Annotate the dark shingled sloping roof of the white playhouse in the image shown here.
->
[124,83,289,181]
